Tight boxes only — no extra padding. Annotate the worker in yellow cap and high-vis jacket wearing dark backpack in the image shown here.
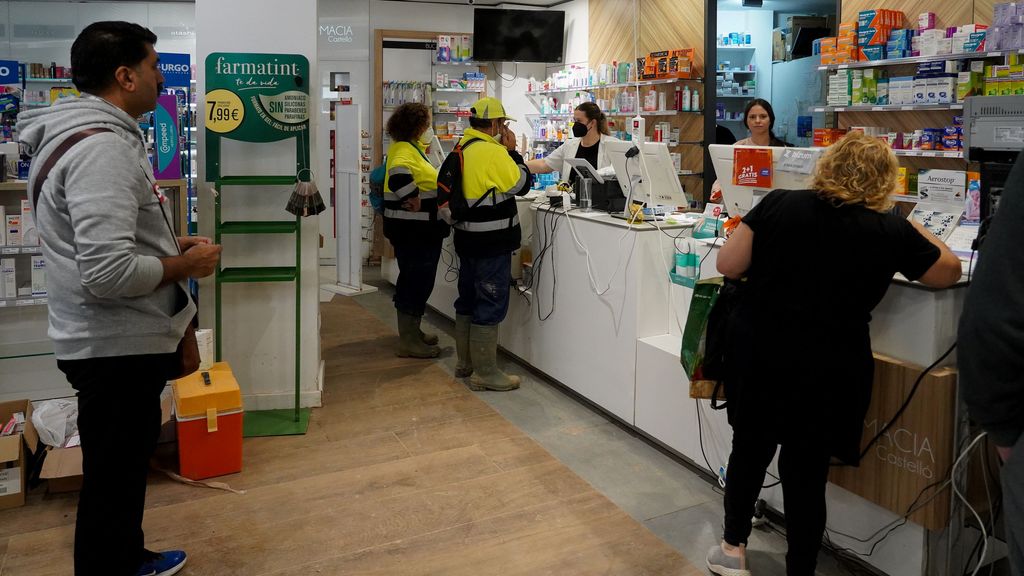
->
[444,97,532,390]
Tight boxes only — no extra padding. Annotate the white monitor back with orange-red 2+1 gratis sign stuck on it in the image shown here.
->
[709,145,824,216]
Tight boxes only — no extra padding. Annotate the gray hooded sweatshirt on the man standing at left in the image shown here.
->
[17,94,196,360]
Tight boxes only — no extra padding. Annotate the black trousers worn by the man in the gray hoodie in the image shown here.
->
[57,354,175,576]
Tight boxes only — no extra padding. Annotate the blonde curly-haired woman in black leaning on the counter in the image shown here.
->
[707,132,961,576]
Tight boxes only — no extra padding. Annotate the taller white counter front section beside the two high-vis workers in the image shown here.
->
[384,201,689,424]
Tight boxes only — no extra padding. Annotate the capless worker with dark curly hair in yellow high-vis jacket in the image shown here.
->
[384,102,451,358]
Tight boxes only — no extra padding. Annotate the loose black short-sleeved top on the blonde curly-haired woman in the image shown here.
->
[727,190,940,461]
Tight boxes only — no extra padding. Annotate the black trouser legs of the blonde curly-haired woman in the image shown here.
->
[724,428,830,576]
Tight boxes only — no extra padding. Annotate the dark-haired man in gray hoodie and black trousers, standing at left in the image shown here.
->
[18,22,220,576]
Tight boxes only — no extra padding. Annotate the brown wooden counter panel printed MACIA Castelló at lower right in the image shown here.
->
[828,355,956,530]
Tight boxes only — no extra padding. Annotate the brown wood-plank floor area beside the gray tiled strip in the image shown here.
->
[0,298,702,576]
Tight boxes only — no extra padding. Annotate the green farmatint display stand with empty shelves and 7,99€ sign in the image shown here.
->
[205,52,309,437]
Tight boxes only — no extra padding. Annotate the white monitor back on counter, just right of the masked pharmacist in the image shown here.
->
[601,140,689,208]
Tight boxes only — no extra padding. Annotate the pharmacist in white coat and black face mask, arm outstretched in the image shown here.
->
[526,102,618,184]
